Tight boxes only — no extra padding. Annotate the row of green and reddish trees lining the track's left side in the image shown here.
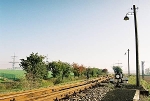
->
[20,53,108,81]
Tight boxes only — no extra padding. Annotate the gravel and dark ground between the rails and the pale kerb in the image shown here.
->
[60,83,136,101]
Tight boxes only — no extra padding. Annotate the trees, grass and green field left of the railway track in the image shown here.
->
[0,53,108,93]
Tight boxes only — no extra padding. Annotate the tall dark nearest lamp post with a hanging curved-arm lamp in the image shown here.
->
[124,5,140,86]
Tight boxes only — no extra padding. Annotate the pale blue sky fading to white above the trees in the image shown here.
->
[0,0,150,73]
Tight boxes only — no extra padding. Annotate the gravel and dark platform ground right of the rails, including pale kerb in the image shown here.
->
[60,83,148,101]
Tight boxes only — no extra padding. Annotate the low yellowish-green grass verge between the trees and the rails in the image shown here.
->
[0,77,80,93]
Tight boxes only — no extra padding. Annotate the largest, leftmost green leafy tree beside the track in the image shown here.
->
[19,53,48,80]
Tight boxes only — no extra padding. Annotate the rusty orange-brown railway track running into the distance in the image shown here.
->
[0,75,113,101]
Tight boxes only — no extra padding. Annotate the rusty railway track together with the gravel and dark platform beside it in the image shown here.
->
[0,76,148,101]
